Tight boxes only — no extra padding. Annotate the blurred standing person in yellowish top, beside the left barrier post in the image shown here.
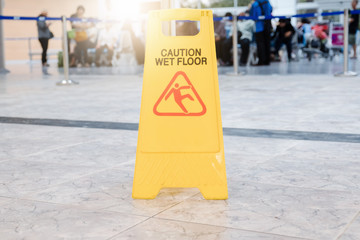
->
[70,5,93,66]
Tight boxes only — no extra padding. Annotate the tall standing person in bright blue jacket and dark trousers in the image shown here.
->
[250,0,272,66]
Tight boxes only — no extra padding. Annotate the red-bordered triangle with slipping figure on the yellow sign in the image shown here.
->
[153,71,206,116]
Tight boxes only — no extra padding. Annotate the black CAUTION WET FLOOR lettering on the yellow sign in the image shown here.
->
[155,48,207,66]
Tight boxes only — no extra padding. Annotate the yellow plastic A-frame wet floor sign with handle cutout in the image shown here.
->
[133,9,228,199]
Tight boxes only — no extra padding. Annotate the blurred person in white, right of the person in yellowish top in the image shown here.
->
[95,23,117,67]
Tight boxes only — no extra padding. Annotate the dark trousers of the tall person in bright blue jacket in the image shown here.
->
[255,30,271,65]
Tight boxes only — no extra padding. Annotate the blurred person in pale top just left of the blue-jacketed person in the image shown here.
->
[238,10,255,66]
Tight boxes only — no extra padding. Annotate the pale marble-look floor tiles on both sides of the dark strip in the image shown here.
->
[0,62,360,240]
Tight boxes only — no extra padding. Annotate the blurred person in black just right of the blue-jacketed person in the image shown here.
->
[274,19,295,62]
